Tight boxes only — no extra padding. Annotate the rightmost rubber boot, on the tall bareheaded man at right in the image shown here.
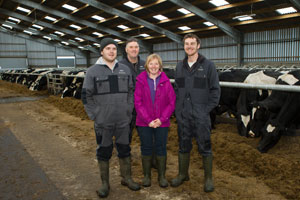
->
[202,156,215,192]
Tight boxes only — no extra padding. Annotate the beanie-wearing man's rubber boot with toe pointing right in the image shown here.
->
[119,156,141,191]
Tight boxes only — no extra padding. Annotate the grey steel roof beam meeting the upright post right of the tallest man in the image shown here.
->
[168,0,242,43]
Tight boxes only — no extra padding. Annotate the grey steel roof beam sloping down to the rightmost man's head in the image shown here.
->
[77,0,182,44]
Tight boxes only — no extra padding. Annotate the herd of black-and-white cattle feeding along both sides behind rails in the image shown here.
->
[0,66,300,153]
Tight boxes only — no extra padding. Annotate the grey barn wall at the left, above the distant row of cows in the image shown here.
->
[0,31,87,69]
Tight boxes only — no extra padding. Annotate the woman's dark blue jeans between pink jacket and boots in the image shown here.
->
[137,126,169,156]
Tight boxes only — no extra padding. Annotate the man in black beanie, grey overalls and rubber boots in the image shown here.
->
[82,38,140,198]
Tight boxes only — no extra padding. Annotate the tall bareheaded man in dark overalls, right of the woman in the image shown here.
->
[171,34,220,192]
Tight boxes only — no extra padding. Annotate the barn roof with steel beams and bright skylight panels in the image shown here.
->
[0,0,300,52]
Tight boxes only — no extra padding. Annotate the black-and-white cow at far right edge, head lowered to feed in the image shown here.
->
[257,71,300,153]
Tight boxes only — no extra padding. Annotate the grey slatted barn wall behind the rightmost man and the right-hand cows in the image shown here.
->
[154,27,300,66]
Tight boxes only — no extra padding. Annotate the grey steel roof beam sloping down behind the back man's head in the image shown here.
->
[12,0,153,52]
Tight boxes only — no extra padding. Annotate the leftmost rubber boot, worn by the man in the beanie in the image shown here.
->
[97,161,109,198]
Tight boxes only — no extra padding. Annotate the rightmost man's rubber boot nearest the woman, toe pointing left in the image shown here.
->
[171,153,190,187]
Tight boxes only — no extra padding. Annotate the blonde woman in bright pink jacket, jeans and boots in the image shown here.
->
[134,54,176,187]
